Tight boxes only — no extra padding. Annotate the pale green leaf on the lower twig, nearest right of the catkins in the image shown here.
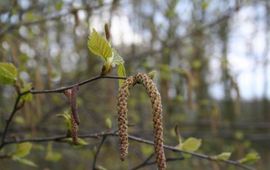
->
[178,137,202,152]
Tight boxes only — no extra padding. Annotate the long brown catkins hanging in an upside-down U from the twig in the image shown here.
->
[118,73,166,170]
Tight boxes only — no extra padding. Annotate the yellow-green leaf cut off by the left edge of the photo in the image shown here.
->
[0,62,18,84]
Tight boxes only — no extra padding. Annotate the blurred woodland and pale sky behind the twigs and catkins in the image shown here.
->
[0,0,270,170]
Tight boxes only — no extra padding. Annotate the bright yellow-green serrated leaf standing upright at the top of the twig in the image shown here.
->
[88,29,112,61]
